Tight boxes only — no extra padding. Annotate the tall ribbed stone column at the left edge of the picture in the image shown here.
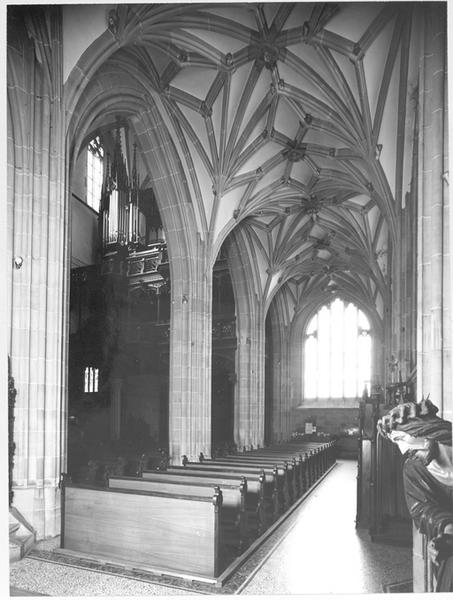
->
[8,6,67,538]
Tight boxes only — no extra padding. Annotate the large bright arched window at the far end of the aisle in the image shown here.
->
[304,298,371,399]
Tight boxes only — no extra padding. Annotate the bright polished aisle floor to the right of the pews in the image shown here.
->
[241,461,412,595]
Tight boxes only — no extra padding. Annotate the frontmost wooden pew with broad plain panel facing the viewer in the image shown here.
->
[61,484,226,578]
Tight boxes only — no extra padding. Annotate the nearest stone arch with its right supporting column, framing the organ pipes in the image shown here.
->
[66,28,219,462]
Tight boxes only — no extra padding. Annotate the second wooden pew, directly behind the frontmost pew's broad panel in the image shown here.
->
[108,471,249,556]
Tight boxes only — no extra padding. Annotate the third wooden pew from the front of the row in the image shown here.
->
[162,463,275,540]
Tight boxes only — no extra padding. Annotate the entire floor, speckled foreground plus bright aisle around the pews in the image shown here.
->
[10,460,412,597]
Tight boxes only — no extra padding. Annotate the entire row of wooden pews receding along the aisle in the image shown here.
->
[61,442,335,581]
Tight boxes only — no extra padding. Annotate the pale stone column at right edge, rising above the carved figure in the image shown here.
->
[417,7,452,419]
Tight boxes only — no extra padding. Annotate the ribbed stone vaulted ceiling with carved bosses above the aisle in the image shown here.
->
[73,2,417,328]
